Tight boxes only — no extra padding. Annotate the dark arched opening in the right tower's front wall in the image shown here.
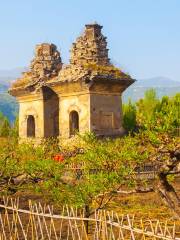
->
[69,111,79,137]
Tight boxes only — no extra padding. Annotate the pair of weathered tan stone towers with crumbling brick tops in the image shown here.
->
[9,24,134,139]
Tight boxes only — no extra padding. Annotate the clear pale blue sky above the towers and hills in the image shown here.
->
[0,0,180,81]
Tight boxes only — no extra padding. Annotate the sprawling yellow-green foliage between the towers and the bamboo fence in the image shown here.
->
[0,127,177,218]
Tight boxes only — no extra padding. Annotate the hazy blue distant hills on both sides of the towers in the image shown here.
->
[0,68,180,122]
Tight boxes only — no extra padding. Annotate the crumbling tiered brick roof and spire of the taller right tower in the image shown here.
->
[59,23,130,82]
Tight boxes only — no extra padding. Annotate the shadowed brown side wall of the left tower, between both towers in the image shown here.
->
[42,86,59,137]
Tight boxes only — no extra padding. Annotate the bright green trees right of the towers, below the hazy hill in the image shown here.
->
[123,89,180,132]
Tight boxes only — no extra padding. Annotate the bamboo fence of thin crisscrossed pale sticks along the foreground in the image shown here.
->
[0,198,180,240]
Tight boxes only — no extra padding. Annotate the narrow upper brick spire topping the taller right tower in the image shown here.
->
[70,23,110,66]
